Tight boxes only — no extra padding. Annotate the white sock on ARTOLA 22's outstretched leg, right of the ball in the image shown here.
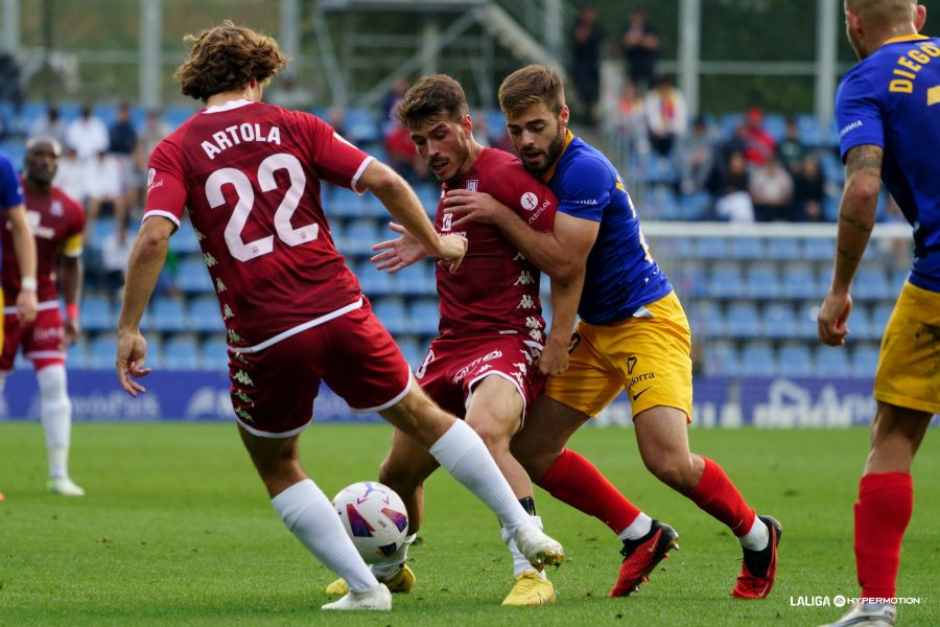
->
[428,420,531,533]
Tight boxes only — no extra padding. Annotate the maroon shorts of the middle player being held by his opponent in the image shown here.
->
[415,334,545,418]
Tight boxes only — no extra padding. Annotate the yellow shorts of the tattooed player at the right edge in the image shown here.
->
[875,283,940,414]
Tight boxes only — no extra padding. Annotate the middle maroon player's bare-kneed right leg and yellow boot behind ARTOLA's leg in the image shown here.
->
[466,376,556,607]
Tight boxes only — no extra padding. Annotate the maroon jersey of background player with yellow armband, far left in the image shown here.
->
[3,183,85,306]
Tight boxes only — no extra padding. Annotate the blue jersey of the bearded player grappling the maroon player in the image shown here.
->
[546,131,672,324]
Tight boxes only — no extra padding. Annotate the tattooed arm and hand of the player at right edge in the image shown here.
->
[818,144,884,346]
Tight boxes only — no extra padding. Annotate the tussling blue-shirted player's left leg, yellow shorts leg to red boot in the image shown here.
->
[512,324,678,596]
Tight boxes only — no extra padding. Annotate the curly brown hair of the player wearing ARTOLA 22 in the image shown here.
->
[176,20,287,102]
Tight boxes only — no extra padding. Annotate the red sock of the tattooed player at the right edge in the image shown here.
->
[855,472,914,599]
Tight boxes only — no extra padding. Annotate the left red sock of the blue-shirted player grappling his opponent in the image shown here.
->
[536,449,640,534]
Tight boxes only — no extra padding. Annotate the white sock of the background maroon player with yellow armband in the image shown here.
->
[36,364,72,479]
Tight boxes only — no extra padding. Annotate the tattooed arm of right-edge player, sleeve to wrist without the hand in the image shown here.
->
[832,145,883,292]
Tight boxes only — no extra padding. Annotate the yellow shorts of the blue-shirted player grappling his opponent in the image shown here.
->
[545,292,692,420]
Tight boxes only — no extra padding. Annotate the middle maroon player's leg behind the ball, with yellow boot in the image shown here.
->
[326,429,438,596]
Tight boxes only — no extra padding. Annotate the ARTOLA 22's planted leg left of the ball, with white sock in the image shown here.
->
[238,424,391,609]
